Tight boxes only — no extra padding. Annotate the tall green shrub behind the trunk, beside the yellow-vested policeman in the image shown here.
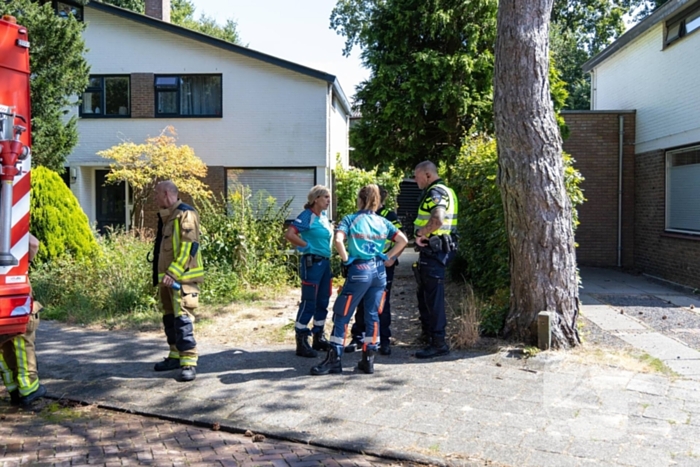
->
[450,136,585,334]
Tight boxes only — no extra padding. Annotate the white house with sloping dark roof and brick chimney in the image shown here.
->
[63,0,351,232]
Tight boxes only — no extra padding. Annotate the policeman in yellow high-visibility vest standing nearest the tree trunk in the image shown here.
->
[414,161,458,358]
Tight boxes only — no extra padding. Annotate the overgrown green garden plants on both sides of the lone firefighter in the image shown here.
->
[31,188,296,329]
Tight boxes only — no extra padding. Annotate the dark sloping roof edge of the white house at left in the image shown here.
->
[86,1,351,113]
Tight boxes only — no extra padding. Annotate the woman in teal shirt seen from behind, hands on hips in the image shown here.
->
[311,185,408,375]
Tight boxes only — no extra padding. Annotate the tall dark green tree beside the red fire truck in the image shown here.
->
[0,0,90,172]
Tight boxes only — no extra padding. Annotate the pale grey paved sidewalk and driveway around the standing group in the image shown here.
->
[8,270,700,467]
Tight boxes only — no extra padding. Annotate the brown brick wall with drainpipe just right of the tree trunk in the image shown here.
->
[563,111,636,269]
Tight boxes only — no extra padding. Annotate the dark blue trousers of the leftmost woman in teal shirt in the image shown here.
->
[294,255,333,333]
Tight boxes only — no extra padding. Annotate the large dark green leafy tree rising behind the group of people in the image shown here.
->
[331,0,497,169]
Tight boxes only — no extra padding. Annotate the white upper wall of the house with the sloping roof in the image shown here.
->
[69,8,328,167]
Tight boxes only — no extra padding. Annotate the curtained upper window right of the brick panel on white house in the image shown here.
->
[155,75,222,117]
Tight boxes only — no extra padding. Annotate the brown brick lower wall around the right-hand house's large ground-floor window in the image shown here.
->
[635,150,700,288]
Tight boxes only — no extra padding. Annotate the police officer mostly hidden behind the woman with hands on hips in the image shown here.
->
[345,186,401,355]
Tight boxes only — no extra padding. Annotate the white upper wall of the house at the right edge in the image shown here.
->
[591,23,700,154]
